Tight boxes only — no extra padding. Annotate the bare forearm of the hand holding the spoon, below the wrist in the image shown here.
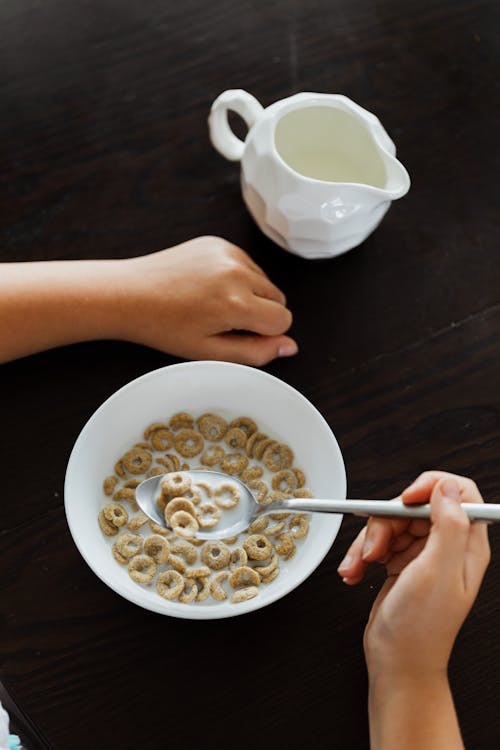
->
[368,673,464,750]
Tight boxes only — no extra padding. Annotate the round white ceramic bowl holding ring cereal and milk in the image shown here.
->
[64,362,346,619]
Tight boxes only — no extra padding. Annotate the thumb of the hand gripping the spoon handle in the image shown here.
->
[426,478,470,576]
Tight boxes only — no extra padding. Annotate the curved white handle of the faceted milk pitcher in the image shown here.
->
[208,89,264,161]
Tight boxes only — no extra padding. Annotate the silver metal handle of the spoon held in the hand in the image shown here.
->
[273,498,500,522]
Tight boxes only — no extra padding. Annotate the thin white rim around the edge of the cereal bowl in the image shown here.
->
[64,360,347,620]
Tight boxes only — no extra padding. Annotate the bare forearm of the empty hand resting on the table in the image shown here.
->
[0,260,126,362]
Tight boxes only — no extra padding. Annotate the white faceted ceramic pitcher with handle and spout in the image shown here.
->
[209,89,410,258]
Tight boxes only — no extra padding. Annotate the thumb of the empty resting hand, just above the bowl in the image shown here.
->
[198,333,298,367]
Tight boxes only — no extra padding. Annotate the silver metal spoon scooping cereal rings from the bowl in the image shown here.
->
[136,469,500,540]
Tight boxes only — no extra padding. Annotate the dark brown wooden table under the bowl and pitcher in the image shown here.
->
[0,0,500,750]
